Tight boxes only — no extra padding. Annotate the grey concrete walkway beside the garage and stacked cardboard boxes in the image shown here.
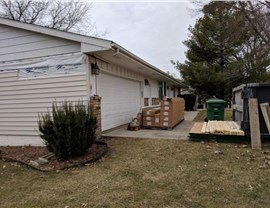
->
[103,111,198,140]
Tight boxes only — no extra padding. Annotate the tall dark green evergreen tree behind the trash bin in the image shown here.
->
[175,1,269,99]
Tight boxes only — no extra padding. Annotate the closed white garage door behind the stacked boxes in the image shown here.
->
[99,74,141,131]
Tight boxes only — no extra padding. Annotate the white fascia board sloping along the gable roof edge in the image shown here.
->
[0,18,112,48]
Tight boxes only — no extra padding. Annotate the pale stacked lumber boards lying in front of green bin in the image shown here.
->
[201,121,245,136]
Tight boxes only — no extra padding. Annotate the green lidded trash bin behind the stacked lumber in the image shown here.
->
[206,99,226,121]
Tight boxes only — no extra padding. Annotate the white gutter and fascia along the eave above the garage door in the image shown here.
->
[112,42,183,86]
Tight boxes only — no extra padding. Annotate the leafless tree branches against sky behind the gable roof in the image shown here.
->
[0,0,106,36]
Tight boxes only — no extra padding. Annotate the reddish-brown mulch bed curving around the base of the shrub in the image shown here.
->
[0,142,107,171]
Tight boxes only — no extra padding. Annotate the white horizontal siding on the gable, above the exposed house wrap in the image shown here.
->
[0,25,81,61]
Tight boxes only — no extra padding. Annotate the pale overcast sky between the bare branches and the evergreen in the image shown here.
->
[91,0,196,77]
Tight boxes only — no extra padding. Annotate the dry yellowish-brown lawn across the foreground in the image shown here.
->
[0,139,270,208]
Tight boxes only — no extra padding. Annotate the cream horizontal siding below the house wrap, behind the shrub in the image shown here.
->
[0,71,87,136]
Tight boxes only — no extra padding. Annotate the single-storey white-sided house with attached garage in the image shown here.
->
[0,18,184,145]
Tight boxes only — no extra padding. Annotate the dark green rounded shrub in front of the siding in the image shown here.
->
[38,101,97,159]
